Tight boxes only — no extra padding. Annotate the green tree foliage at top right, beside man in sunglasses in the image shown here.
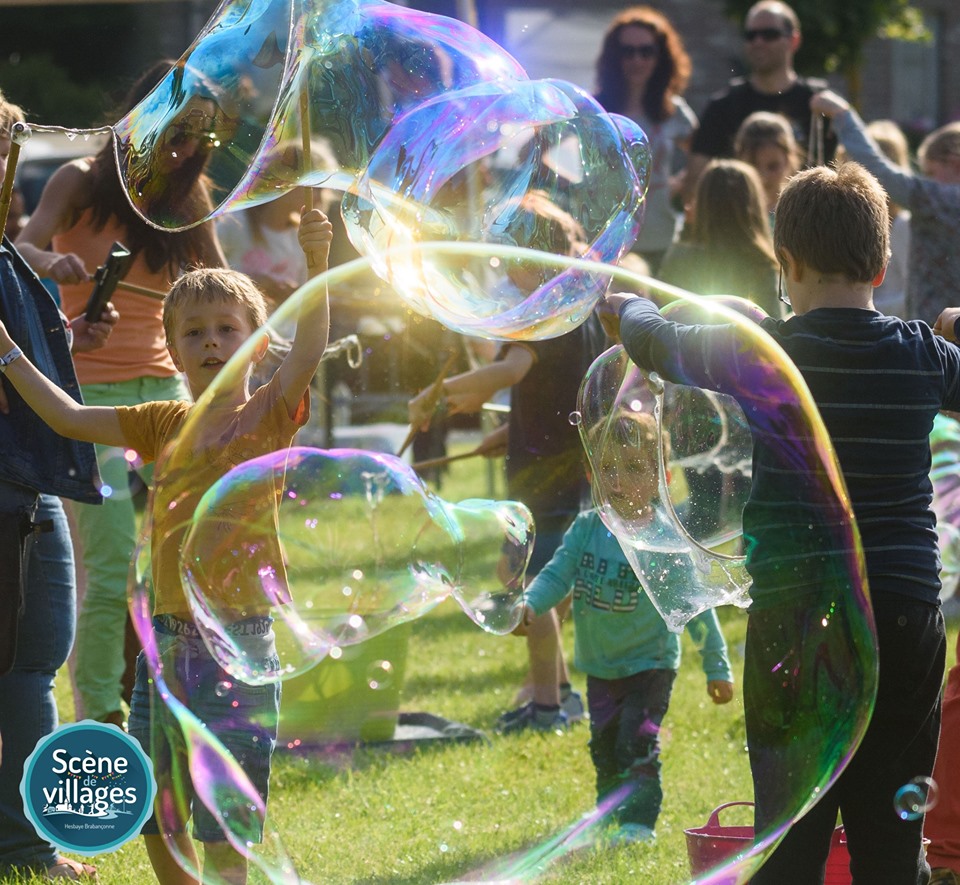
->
[724,0,930,76]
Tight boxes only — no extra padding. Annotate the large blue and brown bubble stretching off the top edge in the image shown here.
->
[114,0,526,228]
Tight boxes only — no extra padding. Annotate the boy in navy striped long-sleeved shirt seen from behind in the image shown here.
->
[608,163,960,885]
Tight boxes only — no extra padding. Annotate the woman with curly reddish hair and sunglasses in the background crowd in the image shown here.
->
[596,6,697,274]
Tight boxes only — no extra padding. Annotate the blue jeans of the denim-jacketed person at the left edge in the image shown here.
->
[0,482,76,869]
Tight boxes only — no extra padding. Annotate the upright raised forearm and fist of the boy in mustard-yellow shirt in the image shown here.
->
[277,209,333,408]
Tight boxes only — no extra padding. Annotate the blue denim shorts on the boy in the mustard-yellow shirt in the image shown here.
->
[129,615,280,842]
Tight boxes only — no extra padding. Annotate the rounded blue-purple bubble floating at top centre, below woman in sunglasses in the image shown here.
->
[343,80,647,338]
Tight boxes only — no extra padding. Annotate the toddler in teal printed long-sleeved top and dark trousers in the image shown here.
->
[514,412,733,842]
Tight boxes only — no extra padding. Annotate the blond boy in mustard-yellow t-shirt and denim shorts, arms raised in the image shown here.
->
[0,210,333,883]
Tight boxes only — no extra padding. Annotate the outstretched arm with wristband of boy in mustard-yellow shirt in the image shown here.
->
[0,322,126,446]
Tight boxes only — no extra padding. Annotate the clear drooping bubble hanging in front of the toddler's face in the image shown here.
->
[578,336,752,632]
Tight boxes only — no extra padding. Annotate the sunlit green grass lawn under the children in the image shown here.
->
[3,442,956,885]
